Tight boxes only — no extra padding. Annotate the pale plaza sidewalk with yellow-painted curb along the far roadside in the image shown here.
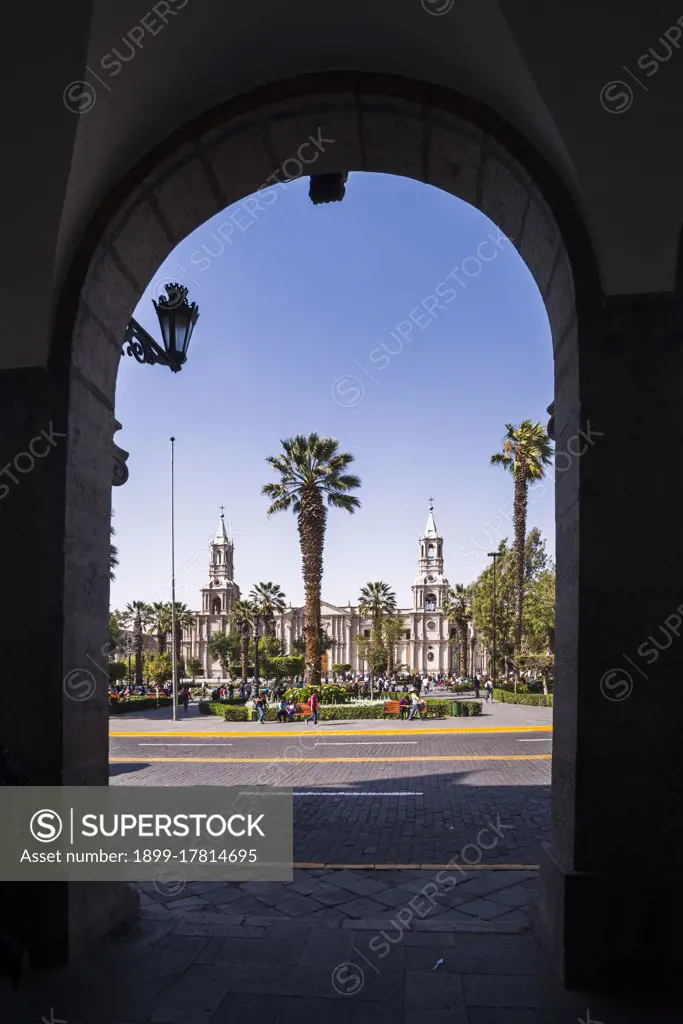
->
[110,703,553,738]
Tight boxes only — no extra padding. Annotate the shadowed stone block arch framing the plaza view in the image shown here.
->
[33,73,599,956]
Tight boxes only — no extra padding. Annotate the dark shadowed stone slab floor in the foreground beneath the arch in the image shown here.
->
[0,908,680,1024]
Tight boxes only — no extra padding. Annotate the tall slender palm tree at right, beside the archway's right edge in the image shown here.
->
[490,420,553,689]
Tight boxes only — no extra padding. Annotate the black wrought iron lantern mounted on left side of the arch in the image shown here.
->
[124,284,200,374]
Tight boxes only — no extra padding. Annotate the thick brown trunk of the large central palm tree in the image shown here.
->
[299,486,327,686]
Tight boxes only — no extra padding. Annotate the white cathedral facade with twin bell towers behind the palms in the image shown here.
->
[183,504,480,679]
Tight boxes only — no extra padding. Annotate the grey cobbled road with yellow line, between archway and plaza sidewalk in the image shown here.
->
[111,733,551,865]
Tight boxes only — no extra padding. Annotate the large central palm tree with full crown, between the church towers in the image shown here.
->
[262,434,360,686]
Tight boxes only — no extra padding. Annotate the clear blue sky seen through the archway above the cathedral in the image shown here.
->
[112,174,554,608]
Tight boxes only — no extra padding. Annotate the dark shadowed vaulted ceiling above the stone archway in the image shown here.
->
[2,0,683,366]
